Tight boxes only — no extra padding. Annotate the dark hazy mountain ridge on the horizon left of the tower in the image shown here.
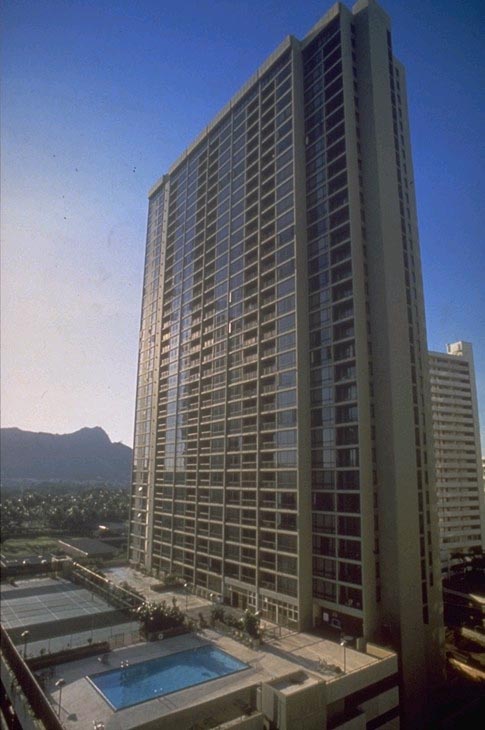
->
[0,427,132,486]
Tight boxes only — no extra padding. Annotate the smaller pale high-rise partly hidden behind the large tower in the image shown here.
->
[429,342,485,573]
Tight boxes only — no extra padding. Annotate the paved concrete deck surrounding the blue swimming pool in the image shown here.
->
[45,629,378,730]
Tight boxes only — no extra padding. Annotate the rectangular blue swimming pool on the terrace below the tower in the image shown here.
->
[87,645,248,710]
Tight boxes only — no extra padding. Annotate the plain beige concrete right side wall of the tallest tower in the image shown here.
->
[354,0,440,717]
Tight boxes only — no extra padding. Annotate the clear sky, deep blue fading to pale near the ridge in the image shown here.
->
[1,0,485,445]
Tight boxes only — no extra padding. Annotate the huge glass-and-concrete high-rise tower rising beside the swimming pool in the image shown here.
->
[130,0,441,707]
